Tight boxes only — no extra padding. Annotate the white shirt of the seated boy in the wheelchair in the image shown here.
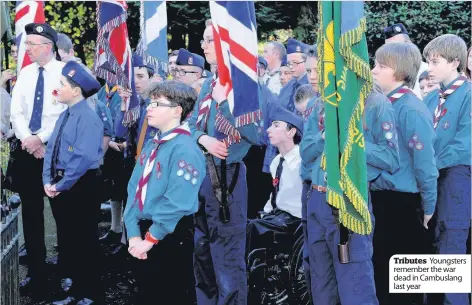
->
[264,145,303,218]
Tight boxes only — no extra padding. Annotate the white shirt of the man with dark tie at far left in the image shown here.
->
[11,59,67,143]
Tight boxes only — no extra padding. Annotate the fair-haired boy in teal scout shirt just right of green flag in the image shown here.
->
[371,42,438,305]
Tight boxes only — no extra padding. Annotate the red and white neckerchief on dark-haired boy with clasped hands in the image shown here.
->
[134,123,190,212]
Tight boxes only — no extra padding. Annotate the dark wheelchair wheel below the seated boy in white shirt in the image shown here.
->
[289,235,312,305]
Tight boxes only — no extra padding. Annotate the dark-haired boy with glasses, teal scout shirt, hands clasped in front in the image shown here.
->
[124,81,205,305]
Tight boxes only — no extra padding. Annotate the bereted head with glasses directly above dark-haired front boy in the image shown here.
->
[174,49,205,86]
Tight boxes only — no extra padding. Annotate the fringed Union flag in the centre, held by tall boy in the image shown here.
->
[210,1,261,146]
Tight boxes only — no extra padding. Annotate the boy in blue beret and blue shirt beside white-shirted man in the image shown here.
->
[43,61,103,305]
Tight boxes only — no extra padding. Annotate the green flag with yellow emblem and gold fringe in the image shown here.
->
[318,1,372,234]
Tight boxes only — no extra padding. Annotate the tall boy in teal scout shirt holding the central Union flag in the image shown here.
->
[189,18,259,305]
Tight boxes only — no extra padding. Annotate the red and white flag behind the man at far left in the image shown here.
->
[15,1,46,75]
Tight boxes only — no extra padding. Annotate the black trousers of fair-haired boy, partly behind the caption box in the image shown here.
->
[371,191,433,305]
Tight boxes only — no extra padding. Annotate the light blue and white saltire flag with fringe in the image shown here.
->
[136,1,168,78]
